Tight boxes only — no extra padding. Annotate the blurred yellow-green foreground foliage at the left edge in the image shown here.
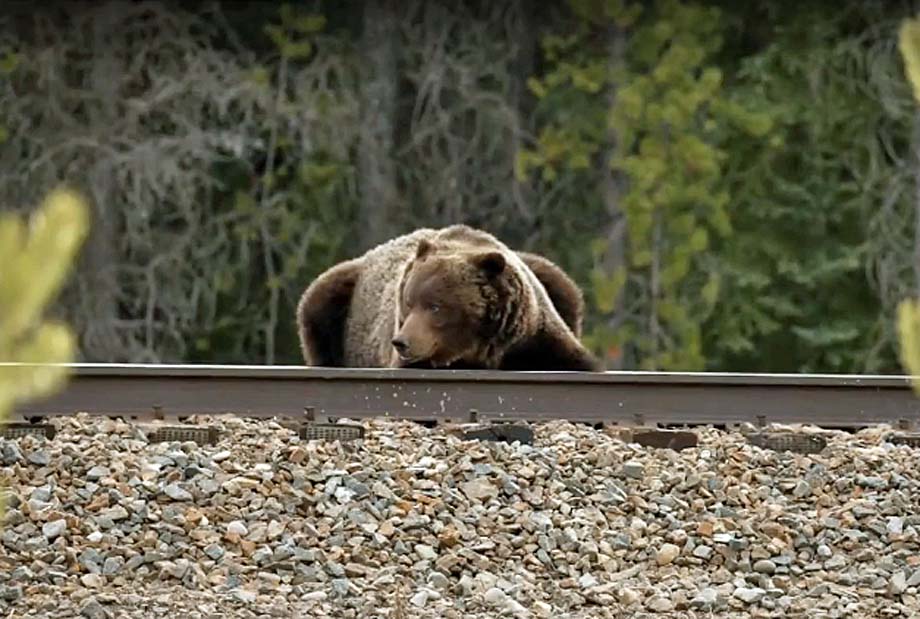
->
[0,191,88,516]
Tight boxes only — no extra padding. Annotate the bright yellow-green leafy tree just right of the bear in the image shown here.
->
[518,0,770,370]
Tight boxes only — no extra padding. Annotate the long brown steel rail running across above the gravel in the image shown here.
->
[7,364,920,428]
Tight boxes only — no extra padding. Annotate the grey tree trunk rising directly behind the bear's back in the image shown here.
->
[358,0,399,249]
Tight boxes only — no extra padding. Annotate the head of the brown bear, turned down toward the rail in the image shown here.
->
[392,240,525,368]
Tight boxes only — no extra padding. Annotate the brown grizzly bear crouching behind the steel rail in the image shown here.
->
[297,224,600,371]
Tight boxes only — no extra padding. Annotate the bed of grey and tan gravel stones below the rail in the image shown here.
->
[0,416,920,619]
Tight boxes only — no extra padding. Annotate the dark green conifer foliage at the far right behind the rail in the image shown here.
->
[704,6,912,372]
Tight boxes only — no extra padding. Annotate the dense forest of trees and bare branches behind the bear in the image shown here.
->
[0,0,920,373]
